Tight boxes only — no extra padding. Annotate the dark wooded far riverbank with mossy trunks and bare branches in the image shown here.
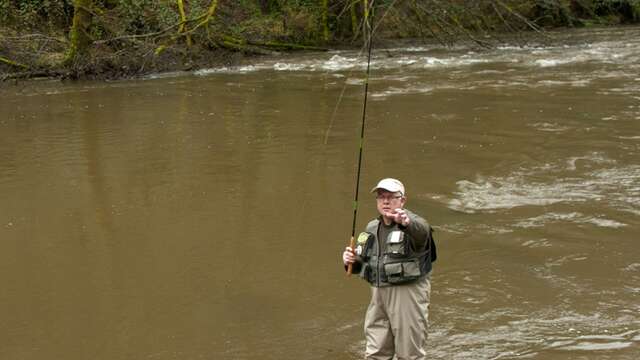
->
[0,0,640,81]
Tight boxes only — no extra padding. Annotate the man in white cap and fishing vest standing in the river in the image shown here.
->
[342,178,436,360]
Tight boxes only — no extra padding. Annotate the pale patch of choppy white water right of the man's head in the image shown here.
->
[448,153,640,215]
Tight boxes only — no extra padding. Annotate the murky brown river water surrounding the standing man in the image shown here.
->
[0,28,640,360]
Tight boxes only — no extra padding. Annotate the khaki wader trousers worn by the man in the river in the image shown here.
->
[364,274,431,360]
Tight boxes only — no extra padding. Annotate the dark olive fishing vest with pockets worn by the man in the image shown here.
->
[356,211,436,287]
